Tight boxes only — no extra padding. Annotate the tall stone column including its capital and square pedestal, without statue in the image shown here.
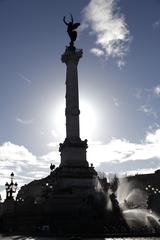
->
[60,47,88,166]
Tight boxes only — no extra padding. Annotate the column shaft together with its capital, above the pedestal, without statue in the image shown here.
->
[62,49,82,139]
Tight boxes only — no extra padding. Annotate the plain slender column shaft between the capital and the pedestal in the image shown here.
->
[65,62,80,138]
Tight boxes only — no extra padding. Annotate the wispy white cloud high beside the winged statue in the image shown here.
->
[82,0,131,67]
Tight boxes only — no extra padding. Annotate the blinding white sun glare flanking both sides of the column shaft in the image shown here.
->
[52,100,97,140]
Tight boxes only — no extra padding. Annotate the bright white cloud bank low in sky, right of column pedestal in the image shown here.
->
[88,129,160,173]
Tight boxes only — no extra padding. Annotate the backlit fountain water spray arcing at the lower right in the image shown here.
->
[117,179,160,234]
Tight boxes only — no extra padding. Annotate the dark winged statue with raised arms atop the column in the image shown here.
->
[63,14,80,48]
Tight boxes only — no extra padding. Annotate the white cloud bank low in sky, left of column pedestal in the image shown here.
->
[0,142,59,198]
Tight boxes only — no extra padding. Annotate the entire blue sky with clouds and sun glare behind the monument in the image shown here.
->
[0,0,160,199]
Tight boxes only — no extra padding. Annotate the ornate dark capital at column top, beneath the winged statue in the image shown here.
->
[61,47,83,65]
